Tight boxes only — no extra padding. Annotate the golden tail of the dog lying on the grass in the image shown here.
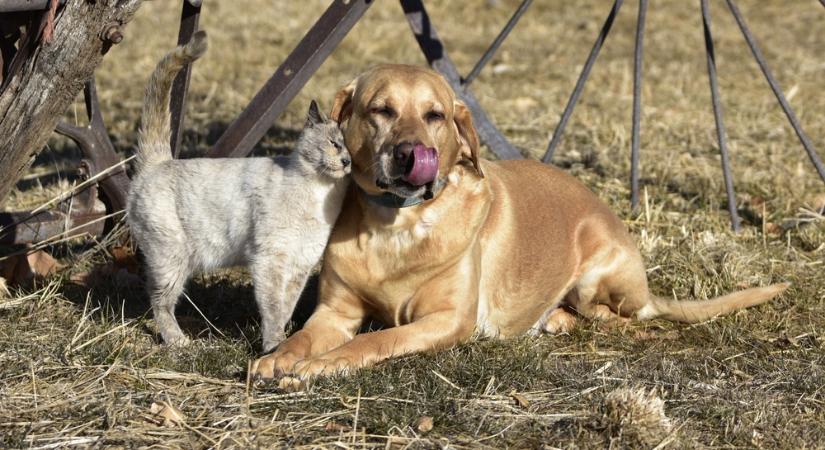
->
[638,283,791,323]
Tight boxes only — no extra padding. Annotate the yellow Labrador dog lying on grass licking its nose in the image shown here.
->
[251,65,788,379]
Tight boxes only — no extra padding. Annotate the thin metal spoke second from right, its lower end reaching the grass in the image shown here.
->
[701,0,740,233]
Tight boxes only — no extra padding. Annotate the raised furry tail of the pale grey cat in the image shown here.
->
[135,31,206,174]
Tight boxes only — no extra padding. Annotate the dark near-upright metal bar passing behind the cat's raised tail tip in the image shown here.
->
[169,0,201,158]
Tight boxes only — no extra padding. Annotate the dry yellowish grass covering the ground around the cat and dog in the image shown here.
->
[0,0,825,448]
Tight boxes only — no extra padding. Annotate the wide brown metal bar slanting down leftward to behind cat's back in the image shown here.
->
[208,0,374,157]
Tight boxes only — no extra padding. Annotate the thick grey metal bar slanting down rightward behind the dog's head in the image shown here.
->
[401,0,522,159]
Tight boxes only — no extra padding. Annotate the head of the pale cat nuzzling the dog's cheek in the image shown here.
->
[295,100,352,178]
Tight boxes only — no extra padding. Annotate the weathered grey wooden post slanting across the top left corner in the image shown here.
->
[0,0,142,206]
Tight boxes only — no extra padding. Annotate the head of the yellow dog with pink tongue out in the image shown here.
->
[331,65,484,198]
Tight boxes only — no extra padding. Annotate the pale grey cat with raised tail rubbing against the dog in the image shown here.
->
[127,31,351,352]
